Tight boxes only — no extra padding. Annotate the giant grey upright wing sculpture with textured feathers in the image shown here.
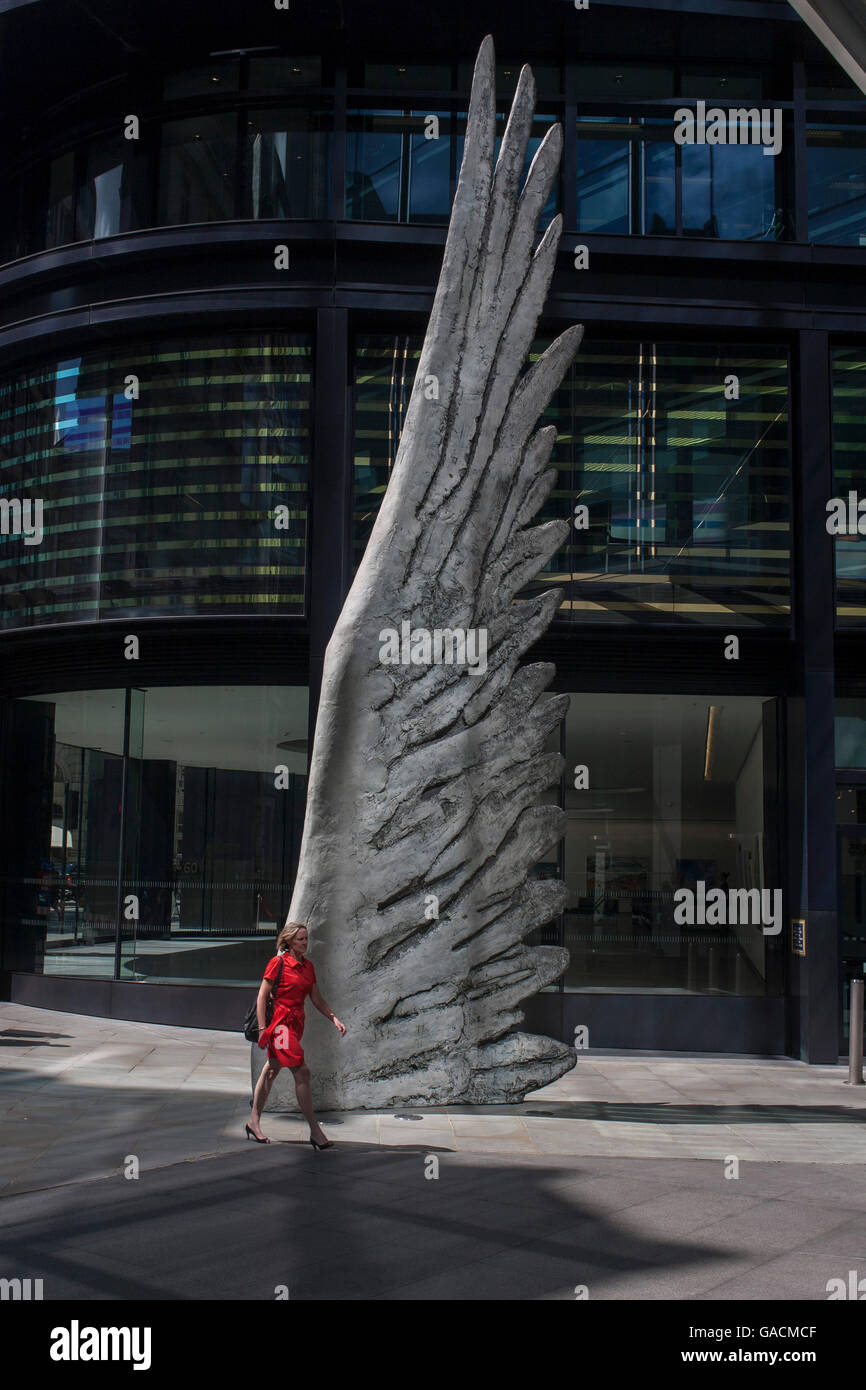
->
[280,38,582,1109]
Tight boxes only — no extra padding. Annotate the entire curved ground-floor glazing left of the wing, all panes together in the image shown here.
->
[4,685,307,984]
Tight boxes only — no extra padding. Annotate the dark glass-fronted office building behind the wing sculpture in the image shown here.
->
[0,0,866,1062]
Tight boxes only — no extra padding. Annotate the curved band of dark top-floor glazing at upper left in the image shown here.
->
[0,65,334,260]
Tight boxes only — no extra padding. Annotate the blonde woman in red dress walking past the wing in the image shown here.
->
[246,922,346,1148]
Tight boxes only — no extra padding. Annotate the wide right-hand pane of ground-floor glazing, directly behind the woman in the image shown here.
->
[124,685,309,984]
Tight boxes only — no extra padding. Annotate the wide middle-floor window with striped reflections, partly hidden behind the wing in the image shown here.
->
[354,334,791,628]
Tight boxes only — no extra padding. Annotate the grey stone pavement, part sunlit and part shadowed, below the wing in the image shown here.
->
[0,1004,866,1300]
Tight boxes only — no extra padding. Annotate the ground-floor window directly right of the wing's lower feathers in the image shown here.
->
[564,694,783,995]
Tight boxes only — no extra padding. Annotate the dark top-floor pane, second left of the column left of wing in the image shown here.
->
[160,114,238,227]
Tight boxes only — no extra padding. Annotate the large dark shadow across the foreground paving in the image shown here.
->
[0,1143,759,1301]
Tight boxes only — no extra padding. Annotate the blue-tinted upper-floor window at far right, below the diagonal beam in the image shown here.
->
[806,124,866,246]
